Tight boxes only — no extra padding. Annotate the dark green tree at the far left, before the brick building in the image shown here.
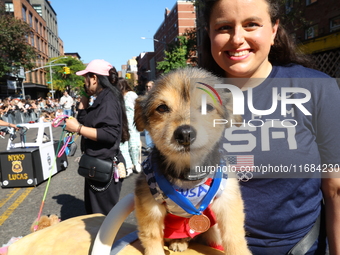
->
[0,1,37,77]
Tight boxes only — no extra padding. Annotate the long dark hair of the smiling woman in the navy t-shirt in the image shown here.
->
[199,0,312,77]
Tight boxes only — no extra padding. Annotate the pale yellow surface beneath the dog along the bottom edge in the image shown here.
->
[8,214,223,255]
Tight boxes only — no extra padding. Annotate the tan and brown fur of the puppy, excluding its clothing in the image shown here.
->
[135,68,251,255]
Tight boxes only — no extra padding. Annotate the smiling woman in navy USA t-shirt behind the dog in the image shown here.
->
[202,0,340,255]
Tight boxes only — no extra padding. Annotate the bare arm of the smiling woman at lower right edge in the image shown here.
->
[322,176,340,255]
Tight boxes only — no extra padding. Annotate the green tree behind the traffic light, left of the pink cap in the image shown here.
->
[46,57,86,96]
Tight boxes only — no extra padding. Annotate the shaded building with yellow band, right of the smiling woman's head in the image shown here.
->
[285,0,340,78]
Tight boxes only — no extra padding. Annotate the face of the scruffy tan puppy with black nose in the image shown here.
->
[135,68,235,175]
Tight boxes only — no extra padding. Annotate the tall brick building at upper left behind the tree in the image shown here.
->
[0,0,64,98]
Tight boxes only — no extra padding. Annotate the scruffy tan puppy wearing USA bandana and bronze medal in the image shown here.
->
[135,68,251,255]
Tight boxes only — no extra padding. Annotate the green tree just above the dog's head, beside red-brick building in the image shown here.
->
[157,36,195,74]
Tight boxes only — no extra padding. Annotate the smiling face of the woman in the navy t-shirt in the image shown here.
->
[208,0,278,78]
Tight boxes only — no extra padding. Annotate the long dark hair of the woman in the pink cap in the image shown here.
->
[86,67,130,143]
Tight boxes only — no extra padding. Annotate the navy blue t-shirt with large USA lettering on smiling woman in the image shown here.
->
[222,65,340,255]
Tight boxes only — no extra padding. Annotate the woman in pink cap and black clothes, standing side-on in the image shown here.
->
[65,59,129,215]
